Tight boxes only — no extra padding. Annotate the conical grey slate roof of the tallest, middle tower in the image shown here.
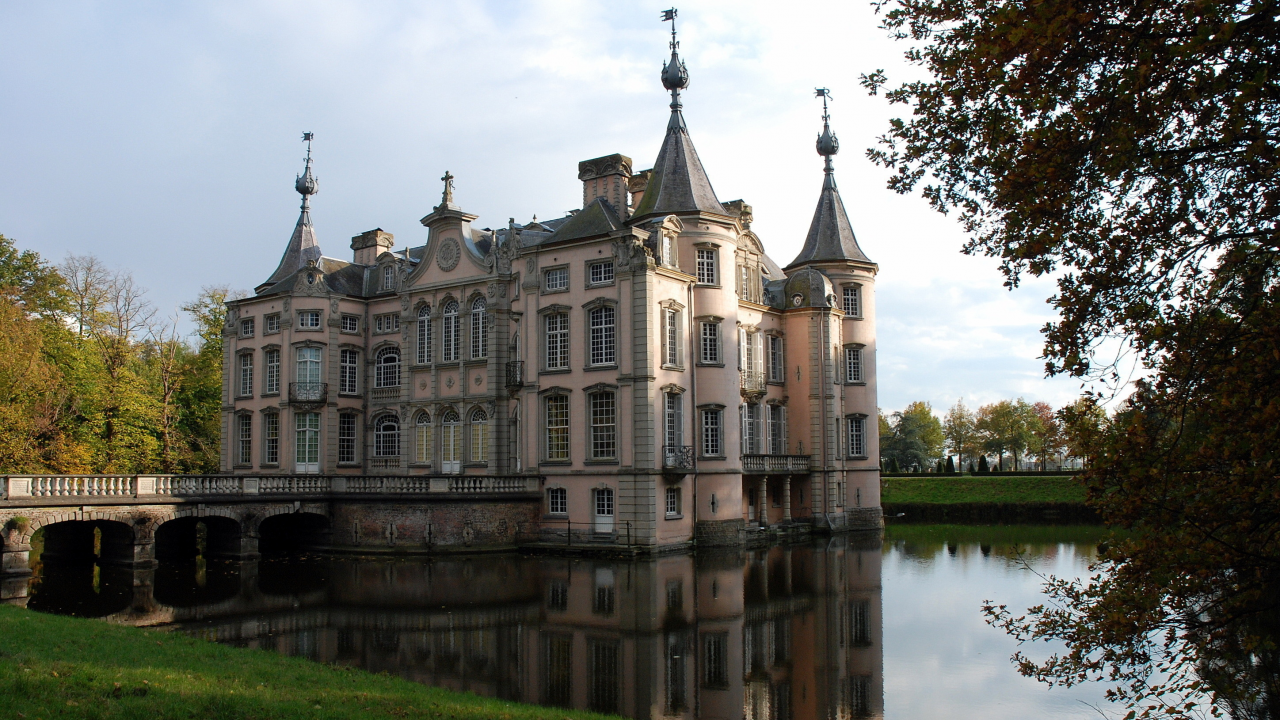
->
[635,109,728,218]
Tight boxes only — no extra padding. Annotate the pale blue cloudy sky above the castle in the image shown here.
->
[0,0,1080,414]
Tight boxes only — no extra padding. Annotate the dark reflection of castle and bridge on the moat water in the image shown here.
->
[28,536,884,720]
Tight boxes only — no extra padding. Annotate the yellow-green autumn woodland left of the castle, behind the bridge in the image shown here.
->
[0,234,228,474]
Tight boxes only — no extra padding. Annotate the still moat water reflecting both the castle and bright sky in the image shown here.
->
[28,525,1114,720]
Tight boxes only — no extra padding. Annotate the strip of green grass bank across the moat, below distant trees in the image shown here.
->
[881,475,1084,505]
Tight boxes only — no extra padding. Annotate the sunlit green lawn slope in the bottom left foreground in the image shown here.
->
[0,606,604,720]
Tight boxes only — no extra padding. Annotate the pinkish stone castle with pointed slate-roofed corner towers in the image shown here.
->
[221,22,882,550]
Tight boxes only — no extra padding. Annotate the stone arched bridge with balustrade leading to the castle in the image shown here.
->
[0,475,543,597]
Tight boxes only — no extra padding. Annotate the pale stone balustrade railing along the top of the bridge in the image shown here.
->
[0,475,543,506]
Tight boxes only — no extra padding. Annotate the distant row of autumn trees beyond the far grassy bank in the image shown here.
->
[879,397,1110,473]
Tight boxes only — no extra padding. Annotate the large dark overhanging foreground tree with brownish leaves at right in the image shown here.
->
[864,0,1280,717]
